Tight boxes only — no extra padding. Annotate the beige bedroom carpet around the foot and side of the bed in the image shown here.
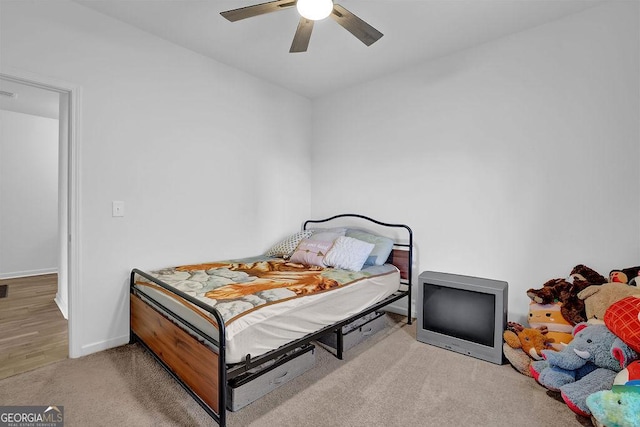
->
[0,318,591,427]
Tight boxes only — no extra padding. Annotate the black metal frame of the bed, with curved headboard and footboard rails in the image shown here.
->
[130,214,413,427]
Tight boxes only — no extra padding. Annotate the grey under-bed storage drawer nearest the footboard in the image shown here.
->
[227,344,316,411]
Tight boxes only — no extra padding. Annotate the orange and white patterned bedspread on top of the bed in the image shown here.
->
[136,257,388,324]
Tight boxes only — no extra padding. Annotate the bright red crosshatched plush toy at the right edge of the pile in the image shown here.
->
[604,296,640,353]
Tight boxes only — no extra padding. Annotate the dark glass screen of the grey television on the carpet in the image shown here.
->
[422,283,496,347]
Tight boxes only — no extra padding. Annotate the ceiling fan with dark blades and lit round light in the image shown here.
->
[220,0,382,53]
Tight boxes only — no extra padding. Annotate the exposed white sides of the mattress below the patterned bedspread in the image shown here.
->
[137,264,400,363]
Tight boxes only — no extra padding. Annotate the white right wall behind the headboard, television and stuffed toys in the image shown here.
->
[312,1,640,321]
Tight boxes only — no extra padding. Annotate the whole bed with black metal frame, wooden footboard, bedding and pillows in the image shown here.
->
[130,214,413,426]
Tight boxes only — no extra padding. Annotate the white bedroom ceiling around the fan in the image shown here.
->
[76,0,609,98]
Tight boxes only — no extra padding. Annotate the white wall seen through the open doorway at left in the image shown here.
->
[0,110,58,278]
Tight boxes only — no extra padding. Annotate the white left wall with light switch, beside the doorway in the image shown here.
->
[0,1,311,354]
